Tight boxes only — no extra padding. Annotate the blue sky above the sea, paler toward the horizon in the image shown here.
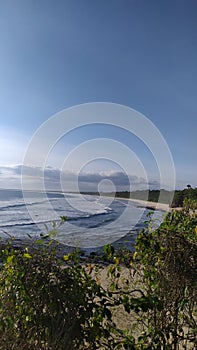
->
[0,0,197,190]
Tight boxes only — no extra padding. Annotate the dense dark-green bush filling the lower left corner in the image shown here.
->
[0,242,117,350]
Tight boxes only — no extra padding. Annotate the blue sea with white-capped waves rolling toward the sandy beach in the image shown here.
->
[0,189,163,251]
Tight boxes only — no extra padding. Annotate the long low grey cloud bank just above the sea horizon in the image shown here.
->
[0,165,155,192]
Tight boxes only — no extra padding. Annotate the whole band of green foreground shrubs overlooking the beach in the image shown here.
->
[0,198,197,350]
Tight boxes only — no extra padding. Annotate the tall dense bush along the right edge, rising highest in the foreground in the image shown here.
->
[136,200,197,349]
